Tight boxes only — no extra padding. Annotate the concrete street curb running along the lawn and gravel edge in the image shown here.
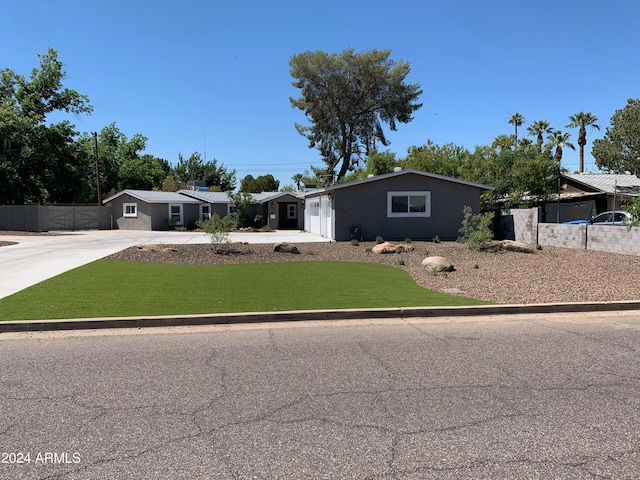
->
[0,301,640,333]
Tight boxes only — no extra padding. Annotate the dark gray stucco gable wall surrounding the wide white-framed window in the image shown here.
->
[332,174,482,241]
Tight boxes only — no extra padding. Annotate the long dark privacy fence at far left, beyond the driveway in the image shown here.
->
[0,205,111,232]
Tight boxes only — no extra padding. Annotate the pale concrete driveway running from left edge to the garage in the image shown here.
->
[0,230,329,298]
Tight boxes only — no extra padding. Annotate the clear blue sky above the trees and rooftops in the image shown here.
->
[0,0,640,186]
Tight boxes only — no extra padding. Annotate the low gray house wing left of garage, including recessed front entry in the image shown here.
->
[103,190,304,230]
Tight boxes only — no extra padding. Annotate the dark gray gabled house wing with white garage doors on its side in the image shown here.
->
[304,170,494,241]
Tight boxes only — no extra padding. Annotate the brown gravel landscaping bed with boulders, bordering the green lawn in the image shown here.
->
[109,242,640,304]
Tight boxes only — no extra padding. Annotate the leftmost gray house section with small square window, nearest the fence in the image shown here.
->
[103,190,201,230]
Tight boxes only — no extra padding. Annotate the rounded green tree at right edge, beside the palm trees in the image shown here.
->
[591,98,640,175]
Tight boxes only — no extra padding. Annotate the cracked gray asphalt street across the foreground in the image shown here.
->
[0,312,640,480]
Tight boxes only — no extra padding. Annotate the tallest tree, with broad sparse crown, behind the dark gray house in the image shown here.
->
[289,49,422,183]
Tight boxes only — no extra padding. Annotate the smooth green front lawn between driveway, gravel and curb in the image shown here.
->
[0,259,487,320]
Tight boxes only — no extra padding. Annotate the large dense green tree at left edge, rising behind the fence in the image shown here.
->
[0,48,92,204]
